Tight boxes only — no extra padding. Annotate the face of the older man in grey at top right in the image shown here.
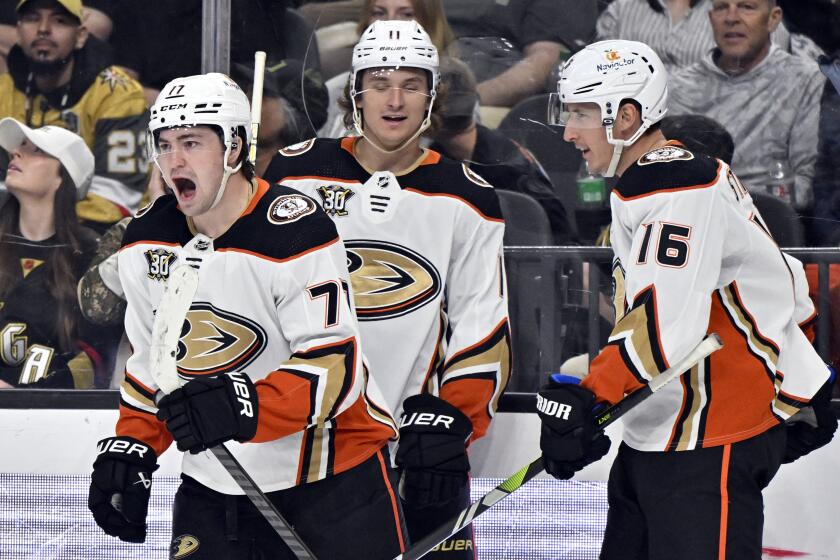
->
[709,0,782,64]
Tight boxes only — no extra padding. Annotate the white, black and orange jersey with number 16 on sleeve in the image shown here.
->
[583,143,828,451]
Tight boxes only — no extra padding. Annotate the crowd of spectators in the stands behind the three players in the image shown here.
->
[0,0,840,388]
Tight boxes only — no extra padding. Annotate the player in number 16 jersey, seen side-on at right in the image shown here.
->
[539,41,837,560]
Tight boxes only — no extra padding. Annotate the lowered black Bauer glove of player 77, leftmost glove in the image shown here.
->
[88,437,157,543]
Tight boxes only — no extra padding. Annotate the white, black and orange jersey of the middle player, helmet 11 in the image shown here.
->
[265,138,511,439]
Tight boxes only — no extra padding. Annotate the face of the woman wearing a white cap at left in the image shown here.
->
[6,140,61,198]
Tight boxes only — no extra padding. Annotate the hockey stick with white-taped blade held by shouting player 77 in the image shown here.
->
[150,236,316,560]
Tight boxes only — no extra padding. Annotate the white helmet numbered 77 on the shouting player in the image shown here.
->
[146,72,251,206]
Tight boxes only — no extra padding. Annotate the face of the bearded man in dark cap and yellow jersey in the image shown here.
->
[18,0,87,70]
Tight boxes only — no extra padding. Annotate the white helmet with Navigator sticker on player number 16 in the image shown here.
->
[548,40,668,177]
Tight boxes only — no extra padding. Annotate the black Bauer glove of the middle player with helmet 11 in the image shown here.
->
[396,394,472,507]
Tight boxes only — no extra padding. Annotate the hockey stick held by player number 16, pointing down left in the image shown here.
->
[394,333,723,560]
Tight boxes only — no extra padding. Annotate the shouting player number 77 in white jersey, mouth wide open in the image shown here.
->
[89,74,406,560]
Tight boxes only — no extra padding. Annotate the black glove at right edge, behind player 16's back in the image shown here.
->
[782,370,837,463]
